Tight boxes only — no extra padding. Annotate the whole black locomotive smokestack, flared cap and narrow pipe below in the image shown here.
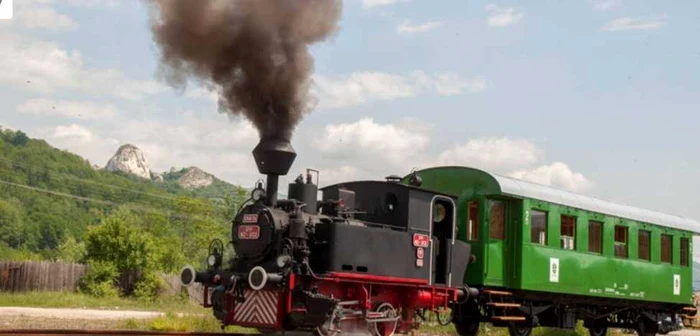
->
[253,136,297,206]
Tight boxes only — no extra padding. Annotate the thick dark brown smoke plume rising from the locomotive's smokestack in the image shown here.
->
[149,0,342,140]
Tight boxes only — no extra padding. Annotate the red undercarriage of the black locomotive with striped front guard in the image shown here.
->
[186,269,474,336]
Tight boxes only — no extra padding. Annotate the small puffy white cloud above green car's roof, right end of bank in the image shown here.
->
[509,162,593,192]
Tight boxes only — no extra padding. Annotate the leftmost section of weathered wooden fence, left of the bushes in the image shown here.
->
[0,261,85,292]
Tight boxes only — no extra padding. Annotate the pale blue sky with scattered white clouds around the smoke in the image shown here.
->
[0,0,700,228]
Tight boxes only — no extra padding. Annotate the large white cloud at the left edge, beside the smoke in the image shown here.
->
[0,34,165,100]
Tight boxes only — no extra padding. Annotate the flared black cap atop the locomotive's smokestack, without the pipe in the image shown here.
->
[253,137,297,175]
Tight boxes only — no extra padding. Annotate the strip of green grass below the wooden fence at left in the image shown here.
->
[0,292,205,314]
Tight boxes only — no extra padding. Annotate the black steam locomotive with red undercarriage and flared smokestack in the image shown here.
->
[181,137,478,336]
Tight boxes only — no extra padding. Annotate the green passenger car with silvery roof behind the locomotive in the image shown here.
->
[403,167,700,335]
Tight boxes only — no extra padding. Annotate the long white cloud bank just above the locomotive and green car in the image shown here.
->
[313,117,592,192]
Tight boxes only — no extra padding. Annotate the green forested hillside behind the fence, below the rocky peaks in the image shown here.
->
[0,130,248,272]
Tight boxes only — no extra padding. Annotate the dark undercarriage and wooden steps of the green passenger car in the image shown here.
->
[452,288,698,336]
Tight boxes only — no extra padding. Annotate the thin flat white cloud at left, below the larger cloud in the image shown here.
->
[17,98,118,120]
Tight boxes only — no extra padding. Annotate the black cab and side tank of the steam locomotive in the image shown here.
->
[312,179,470,287]
